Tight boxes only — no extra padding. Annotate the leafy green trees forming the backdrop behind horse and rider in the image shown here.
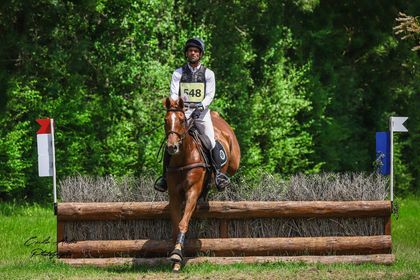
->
[0,0,420,198]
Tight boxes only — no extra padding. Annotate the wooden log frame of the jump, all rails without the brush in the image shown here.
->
[57,201,394,266]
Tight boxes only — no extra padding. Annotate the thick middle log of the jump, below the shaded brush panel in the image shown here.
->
[58,235,391,258]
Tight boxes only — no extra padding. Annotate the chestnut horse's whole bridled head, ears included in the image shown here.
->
[164,97,188,155]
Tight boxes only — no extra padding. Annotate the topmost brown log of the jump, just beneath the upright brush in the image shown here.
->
[58,201,391,221]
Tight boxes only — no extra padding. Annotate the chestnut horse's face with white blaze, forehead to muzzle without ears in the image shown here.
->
[165,111,185,155]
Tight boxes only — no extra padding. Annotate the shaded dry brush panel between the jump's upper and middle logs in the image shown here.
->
[64,218,384,241]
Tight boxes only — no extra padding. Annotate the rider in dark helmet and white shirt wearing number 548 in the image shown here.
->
[154,38,229,192]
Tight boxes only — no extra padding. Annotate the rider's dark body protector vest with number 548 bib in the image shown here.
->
[179,64,206,103]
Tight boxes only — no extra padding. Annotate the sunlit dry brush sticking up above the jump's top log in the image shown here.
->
[59,173,388,202]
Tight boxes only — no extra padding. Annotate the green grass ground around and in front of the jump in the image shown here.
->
[0,197,420,279]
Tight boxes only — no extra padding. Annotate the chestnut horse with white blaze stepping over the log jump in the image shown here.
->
[164,97,241,272]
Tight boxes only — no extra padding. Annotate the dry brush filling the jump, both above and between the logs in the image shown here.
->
[59,173,388,241]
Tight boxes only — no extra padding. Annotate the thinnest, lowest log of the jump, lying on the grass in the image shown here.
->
[60,254,395,267]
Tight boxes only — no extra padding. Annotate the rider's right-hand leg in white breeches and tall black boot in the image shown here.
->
[195,109,230,191]
